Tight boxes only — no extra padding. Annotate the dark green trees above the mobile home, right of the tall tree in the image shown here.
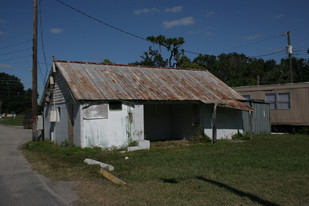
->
[193,53,309,87]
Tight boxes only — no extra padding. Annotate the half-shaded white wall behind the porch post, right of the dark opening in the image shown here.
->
[200,104,243,139]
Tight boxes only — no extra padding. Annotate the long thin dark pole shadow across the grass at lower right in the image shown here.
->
[196,176,279,206]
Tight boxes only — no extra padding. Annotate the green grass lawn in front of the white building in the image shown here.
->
[23,135,309,205]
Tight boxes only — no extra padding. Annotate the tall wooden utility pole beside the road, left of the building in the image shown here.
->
[32,0,38,141]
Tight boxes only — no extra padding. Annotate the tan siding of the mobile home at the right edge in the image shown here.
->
[234,83,309,126]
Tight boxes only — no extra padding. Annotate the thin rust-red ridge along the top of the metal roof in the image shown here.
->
[54,60,206,71]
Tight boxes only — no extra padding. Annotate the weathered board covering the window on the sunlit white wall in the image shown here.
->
[83,104,108,119]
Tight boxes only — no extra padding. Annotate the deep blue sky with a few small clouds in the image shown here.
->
[0,0,309,96]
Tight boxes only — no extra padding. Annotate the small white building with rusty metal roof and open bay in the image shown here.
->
[41,61,252,148]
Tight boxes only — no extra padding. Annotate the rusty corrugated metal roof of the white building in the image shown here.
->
[55,61,252,110]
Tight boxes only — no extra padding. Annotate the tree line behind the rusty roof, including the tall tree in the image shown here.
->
[130,35,309,87]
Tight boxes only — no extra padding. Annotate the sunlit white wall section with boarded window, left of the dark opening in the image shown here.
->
[80,103,144,148]
